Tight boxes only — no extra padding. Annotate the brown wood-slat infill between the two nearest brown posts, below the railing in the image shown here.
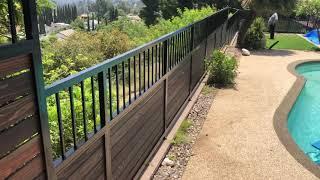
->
[111,84,164,179]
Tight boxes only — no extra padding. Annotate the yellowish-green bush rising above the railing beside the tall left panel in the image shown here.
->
[42,29,131,84]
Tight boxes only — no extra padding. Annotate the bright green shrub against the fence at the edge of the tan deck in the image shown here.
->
[206,51,238,86]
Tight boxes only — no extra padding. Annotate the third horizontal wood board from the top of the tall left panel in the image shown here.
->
[0,95,37,132]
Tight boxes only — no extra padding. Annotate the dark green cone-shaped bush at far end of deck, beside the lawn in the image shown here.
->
[245,17,266,49]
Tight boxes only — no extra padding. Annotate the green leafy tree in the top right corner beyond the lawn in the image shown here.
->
[296,0,320,42]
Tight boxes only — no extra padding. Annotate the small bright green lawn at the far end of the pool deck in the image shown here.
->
[266,34,319,51]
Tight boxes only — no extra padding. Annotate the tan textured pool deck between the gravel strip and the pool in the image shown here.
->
[183,50,320,179]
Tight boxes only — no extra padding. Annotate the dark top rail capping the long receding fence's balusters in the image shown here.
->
[45,7,235,97]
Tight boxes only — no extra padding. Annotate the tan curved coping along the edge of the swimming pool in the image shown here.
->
[273,59,320,178]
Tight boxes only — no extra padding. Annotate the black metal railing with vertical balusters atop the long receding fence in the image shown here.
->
[45,8,239,165]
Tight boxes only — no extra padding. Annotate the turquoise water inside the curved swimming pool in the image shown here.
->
[288,62,320,164]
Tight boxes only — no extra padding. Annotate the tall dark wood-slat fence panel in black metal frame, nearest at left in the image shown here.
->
[0,0,54,179]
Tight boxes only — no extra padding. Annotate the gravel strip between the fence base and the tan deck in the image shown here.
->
[153,86,217,180]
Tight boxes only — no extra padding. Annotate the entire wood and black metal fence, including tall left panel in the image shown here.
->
[0,0,240,179]
